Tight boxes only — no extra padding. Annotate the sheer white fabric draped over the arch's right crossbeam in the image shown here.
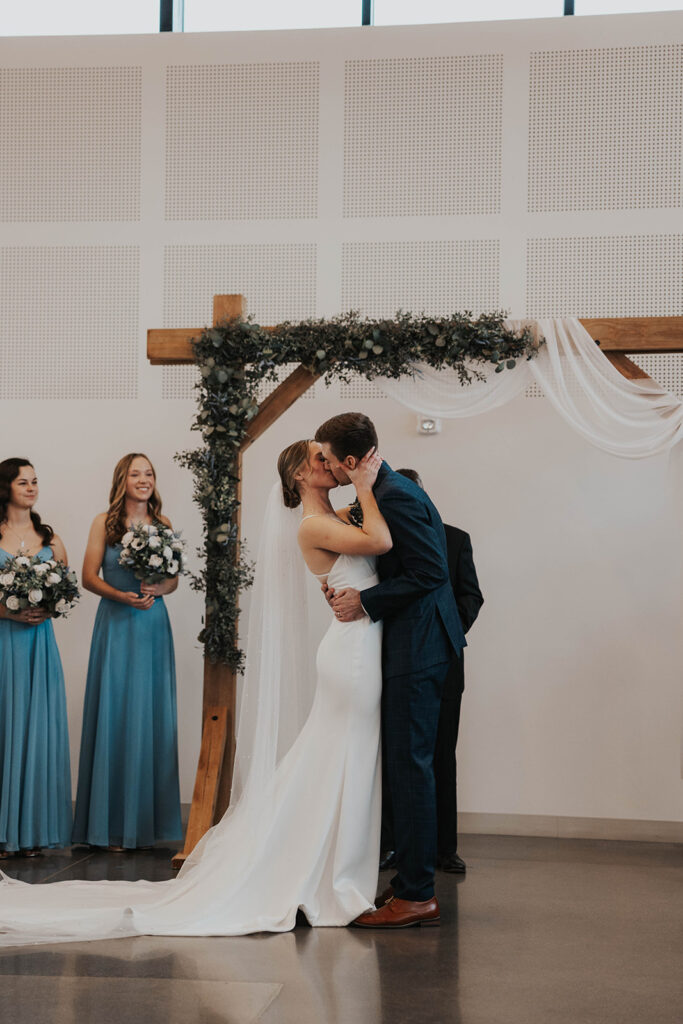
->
[376,317,683,459]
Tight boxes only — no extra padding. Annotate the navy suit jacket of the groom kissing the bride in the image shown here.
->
[360,462,467,679]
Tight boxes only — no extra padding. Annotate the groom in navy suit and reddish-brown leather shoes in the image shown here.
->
[315,413,466,928]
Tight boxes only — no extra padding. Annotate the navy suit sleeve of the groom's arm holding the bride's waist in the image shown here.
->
[360,492,449,622]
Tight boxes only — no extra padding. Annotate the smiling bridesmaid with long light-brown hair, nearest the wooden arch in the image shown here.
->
[73,453,182,852]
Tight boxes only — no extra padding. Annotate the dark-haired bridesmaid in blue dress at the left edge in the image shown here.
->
[0,459,72,859]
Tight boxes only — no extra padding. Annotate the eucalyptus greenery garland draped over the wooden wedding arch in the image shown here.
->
[176,312,542,671]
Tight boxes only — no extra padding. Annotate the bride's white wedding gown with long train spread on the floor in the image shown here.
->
[0,540,382,945]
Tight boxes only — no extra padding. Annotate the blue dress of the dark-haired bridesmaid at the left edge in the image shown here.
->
[0,548,72,852]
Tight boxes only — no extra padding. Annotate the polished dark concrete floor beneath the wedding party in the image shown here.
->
[0,836,683,1024]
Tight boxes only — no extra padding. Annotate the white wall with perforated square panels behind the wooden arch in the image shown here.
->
[0,14,683,821]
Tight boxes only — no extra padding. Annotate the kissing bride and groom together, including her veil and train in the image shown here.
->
[0,413,466,945]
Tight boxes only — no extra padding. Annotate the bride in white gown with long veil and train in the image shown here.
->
[0,440,391,945]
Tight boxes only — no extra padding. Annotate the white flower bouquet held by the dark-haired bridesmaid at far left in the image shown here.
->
[0,555,81,616]
